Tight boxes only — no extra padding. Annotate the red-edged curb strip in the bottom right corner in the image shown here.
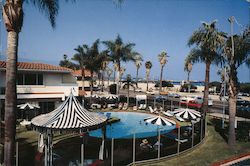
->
[211,152,250,166]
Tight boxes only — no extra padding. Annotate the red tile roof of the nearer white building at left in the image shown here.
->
[0,61,72,72]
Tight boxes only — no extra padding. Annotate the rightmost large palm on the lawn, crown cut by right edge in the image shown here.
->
[224,25,250,150]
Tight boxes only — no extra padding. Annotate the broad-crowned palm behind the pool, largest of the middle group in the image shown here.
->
[103,35,138,93]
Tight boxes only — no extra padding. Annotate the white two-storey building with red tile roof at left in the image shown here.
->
[0,61,78,118]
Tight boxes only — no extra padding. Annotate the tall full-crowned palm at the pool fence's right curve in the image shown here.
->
[186,21,225,113]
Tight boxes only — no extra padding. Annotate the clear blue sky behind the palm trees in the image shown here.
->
[0,0,250,82]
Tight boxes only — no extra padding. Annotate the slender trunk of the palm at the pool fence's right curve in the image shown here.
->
[202,63,211,115]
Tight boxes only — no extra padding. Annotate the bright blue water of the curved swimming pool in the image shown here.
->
[89,112,175,138]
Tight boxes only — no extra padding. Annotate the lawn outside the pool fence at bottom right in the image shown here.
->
[140,118,250,166]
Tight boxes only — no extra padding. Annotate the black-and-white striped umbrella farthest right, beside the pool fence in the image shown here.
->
[173,108,201,120]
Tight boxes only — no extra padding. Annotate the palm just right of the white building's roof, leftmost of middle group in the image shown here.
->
[72,45,88,94]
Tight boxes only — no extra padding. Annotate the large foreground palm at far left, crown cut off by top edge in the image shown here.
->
[2,0,69,166]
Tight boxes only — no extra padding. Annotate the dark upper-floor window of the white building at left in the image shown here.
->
[17,73,43,85]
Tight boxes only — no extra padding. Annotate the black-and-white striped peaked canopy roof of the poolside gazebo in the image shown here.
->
[31,93,107,131]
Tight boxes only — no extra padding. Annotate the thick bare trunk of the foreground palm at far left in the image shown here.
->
[4,31,18,166]
